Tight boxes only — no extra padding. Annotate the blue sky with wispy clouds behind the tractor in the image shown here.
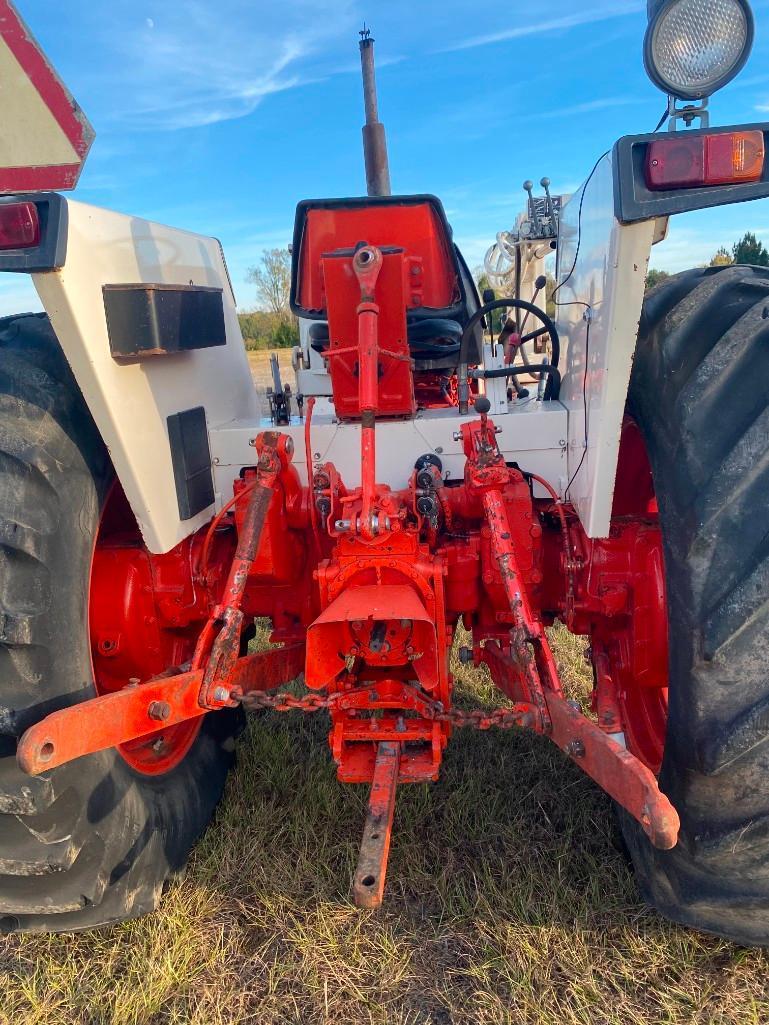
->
[0,0,769,314]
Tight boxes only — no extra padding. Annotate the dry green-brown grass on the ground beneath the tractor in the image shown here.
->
[0,630,769,1025]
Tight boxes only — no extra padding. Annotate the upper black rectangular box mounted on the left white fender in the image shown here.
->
[103,284,227,361]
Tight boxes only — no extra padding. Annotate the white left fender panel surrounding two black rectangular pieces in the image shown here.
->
[33,196,257,552]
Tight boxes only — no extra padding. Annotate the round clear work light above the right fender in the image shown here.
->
[644,0,754,99]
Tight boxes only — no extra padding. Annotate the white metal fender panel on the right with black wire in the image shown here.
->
[556,156,655,537]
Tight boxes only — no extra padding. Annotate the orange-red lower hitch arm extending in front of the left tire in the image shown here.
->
[16,643,305,776]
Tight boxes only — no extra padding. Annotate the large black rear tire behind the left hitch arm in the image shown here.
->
[0,315,235,932]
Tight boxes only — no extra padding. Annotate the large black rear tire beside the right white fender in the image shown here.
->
[620,267,769,945]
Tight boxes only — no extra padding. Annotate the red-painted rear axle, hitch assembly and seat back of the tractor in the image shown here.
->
[19,198,678,903]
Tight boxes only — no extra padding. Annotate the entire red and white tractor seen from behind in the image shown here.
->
[0,0,769,945]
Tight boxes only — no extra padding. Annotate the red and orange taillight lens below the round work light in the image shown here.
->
[646,131,764,189]
